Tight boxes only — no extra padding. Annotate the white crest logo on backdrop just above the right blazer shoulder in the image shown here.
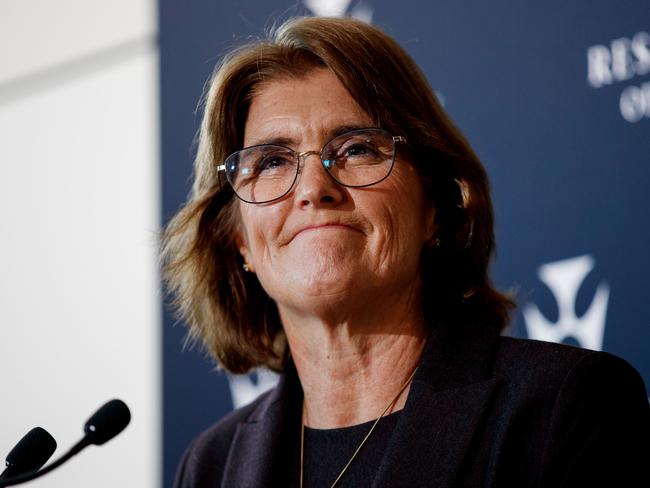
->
[523,254,609,351]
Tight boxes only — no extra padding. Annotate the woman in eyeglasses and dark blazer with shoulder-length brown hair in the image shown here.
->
[163,18,650,487]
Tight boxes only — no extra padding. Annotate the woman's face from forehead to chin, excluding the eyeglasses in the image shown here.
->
[237,69,435,313]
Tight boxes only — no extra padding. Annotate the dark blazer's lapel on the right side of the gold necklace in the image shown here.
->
[372,326,501,488]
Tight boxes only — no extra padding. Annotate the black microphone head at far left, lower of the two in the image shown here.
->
[0,427,56,481]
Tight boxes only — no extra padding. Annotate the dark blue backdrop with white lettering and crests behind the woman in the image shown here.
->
[160,0,650,486]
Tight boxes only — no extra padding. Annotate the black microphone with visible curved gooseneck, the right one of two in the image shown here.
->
[0,400,131,488]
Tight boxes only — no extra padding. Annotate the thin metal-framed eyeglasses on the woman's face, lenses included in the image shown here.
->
[217,128,406,204]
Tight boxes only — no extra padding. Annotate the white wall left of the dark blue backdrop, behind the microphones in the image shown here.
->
[0,1,161,488]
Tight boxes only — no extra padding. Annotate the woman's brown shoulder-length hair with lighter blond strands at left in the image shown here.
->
[161,17,513,373]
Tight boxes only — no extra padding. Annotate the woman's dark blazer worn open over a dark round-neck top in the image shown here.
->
[176,322,650,488]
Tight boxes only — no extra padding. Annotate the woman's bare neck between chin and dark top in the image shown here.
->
[281,292,427,429]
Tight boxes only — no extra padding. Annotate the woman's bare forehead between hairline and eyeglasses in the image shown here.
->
[244,68,375,146]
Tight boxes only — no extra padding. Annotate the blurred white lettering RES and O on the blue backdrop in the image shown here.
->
[587,31,650,122]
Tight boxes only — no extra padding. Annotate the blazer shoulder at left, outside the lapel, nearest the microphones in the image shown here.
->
[174,390,274,488]
